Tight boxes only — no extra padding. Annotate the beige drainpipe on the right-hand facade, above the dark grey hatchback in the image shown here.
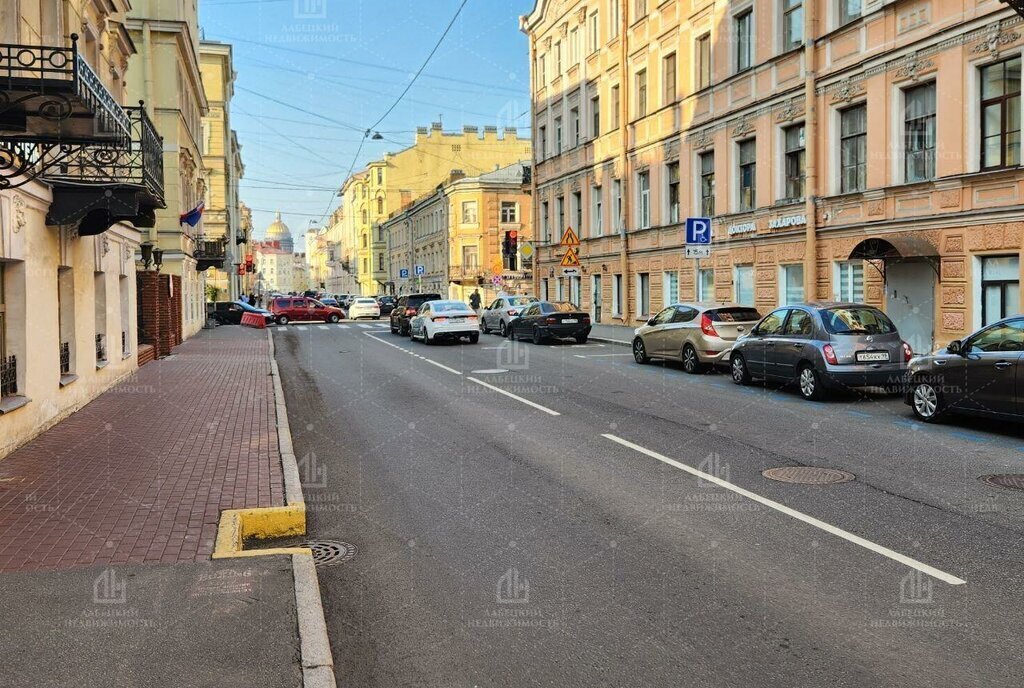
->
[804,2,818,301]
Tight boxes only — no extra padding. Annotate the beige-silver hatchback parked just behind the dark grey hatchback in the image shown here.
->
[633,303,761,374]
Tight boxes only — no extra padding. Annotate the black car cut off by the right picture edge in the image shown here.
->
[905,315,1024,423]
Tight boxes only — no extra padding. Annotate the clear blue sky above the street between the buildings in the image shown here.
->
[200,0,534,243]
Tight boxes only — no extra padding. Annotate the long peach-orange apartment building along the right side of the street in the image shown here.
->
[520,0,1024,351]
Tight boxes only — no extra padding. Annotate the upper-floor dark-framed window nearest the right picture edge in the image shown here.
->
[981,56,1021,170]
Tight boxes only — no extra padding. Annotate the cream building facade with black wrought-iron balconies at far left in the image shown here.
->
[0,0,163,458]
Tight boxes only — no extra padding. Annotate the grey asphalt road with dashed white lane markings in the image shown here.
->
[274,324,1024,687]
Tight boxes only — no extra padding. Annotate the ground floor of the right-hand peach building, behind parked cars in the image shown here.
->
[535,220,1024,352]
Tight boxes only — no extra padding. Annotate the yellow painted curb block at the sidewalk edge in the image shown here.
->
[212,502,309,559]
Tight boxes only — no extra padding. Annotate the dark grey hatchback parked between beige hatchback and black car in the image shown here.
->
[729,303,913,399]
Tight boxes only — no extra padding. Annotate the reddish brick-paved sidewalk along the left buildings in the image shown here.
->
[0,327,285,572]
